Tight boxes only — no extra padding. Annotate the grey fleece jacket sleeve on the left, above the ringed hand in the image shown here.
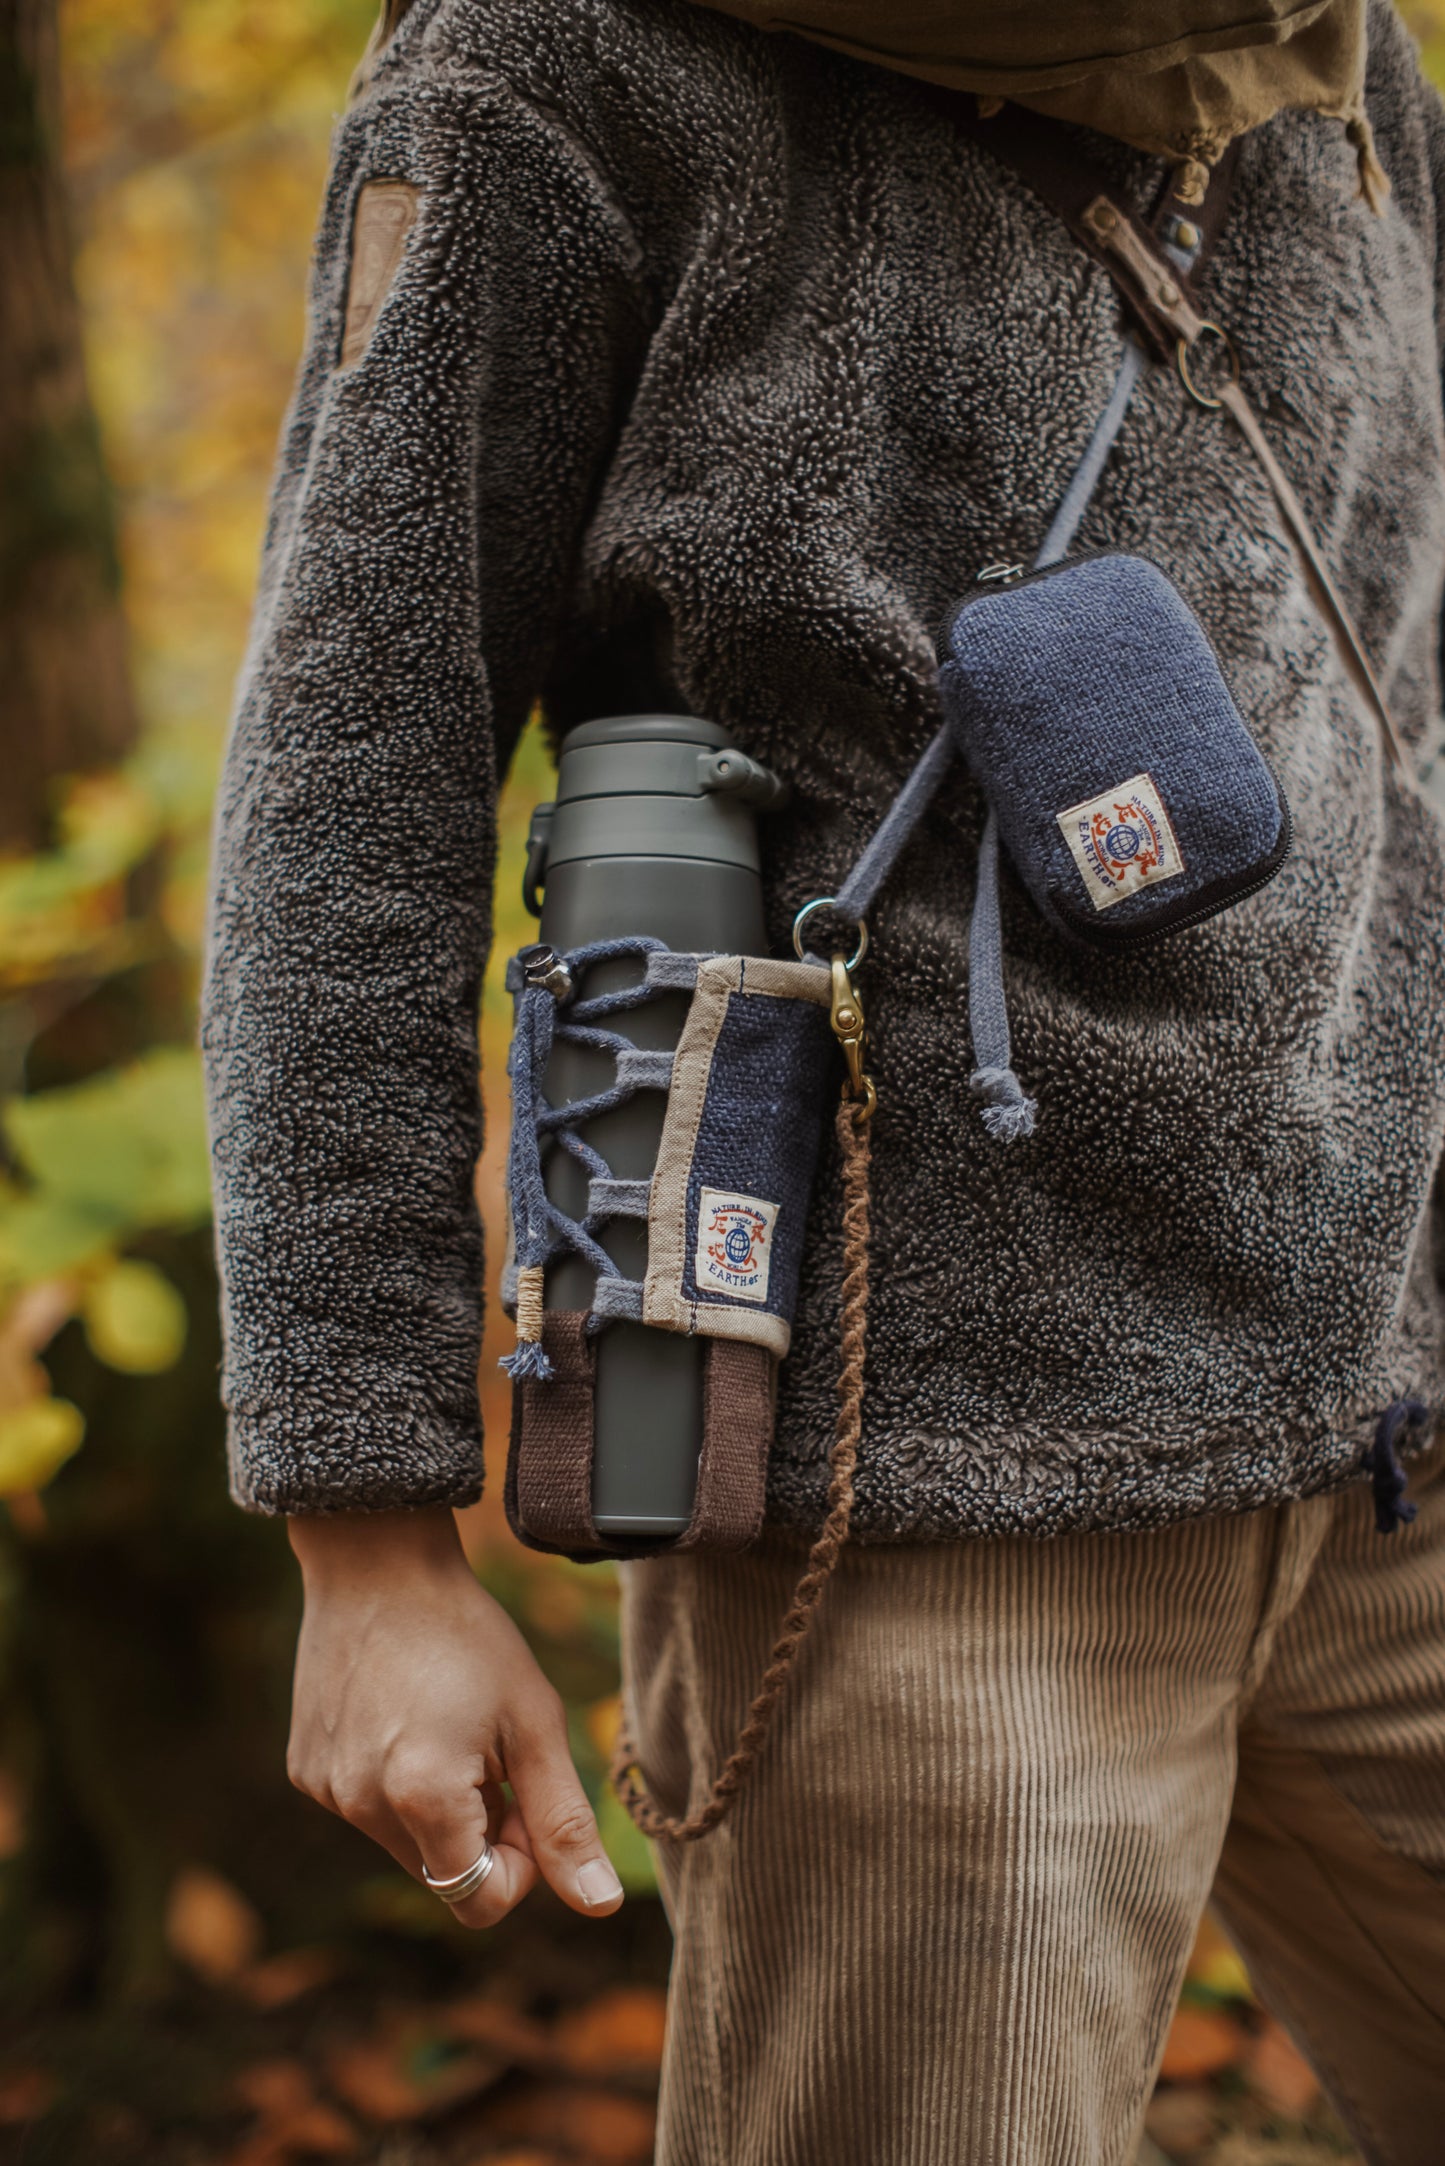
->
[201,50,643,1512]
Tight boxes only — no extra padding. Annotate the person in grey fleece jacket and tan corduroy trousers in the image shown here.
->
[204,0,1445,2166]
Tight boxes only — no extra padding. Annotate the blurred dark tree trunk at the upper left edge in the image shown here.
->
[0,0,136,849]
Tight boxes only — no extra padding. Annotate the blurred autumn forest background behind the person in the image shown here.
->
[0,0,1445,2166]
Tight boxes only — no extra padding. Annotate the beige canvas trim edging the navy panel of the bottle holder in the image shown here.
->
[641,955,830,1360]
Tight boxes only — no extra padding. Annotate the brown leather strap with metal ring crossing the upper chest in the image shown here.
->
[927,97,1415,780]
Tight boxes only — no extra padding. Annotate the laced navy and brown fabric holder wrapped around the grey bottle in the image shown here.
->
[503,938,836,1557]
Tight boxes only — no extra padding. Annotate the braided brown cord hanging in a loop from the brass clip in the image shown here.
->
[611,1098,871,1843]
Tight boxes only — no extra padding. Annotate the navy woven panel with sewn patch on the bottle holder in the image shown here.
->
[682,994,836,1323]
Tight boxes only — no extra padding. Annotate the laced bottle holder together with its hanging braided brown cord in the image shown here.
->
[507,936,875,1841]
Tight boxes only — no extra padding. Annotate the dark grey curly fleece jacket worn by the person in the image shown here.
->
[204,0,1445,1540]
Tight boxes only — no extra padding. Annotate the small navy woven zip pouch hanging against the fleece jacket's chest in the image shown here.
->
[940,550,1291,949]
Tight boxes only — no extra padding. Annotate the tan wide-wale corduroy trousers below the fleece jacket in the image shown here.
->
[624,1447,1445,2166]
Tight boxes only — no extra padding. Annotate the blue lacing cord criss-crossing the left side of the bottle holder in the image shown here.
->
[500,936,665,1382]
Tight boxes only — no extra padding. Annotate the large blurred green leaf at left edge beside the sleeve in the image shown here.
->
[4,1046,210,1228]
